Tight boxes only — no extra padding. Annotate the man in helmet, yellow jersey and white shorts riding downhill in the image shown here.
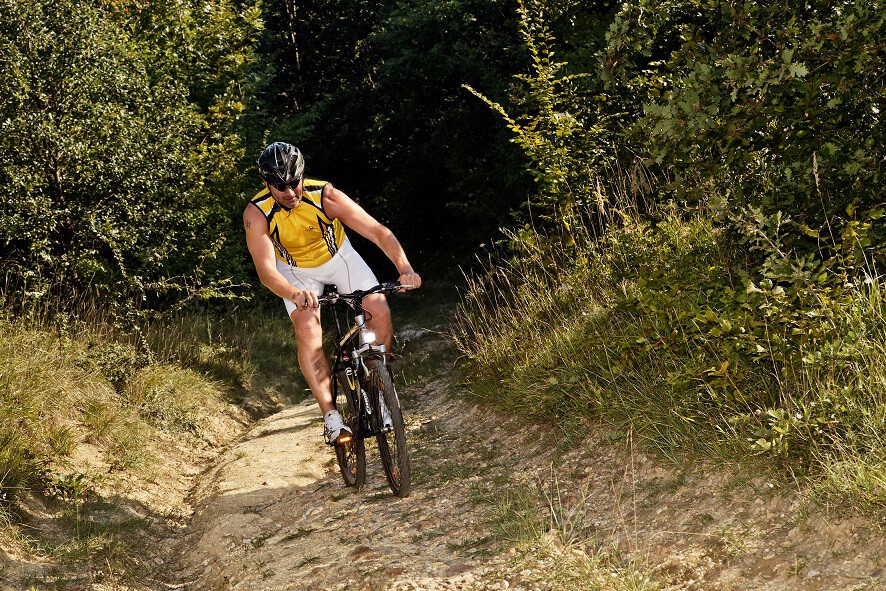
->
[243,142,421,443]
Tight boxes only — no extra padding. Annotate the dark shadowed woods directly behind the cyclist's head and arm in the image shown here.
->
[255,0,529,264]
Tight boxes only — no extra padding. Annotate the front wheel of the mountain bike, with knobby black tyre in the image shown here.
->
[366,359,412,497]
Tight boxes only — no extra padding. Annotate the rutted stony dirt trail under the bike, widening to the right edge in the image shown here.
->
[169,328,886,591]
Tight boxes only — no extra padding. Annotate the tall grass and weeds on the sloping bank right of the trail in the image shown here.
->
[456,199,886,508]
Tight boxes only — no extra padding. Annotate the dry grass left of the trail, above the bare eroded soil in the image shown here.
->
[0,294,304,504]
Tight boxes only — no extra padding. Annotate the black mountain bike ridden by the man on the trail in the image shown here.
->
[319,283,412,497]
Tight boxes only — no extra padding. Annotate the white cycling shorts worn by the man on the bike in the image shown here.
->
[277,240,378,316]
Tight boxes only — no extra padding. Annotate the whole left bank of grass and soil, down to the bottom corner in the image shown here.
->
[0,294,304,588]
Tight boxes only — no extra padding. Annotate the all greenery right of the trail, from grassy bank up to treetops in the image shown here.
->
[457,0,886,503]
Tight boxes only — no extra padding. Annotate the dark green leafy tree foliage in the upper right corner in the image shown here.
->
[601,0,886,228]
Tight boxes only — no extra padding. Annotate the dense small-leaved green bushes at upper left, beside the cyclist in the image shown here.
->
[0,0,258,314]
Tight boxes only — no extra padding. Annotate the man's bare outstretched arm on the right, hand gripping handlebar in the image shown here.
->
[323,184,421,287]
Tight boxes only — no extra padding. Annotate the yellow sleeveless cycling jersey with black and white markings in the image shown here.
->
[250,179,345,267]
